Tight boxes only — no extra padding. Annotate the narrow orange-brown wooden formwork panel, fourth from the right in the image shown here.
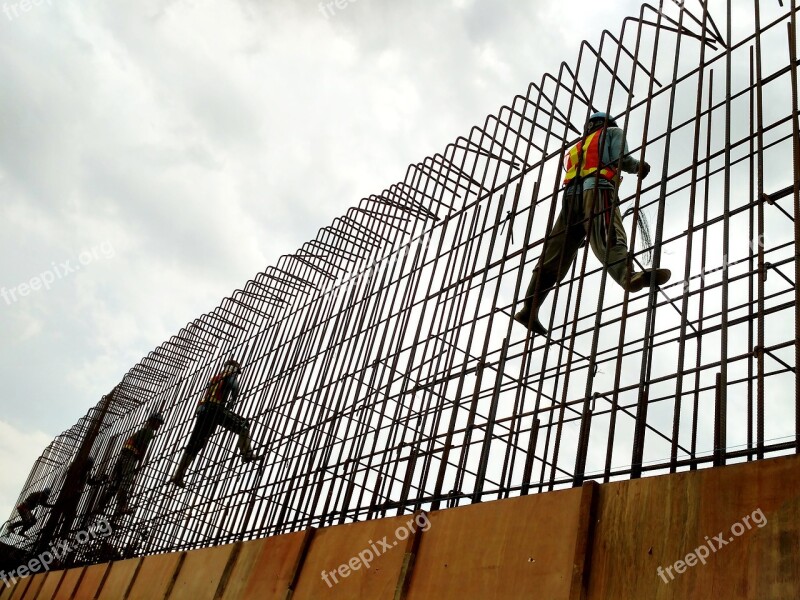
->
[220,531,306,600]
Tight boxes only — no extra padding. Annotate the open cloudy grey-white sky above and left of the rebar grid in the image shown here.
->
[0,0,688,515]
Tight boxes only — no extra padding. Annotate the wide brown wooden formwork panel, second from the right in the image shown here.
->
[407,489,582,600]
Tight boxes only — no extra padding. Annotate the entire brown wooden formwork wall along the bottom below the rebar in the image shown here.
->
[7,456,800,600]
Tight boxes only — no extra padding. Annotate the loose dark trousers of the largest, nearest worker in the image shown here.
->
[525,187,629,309]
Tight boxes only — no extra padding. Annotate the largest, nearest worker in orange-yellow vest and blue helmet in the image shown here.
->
[514,112,671,336]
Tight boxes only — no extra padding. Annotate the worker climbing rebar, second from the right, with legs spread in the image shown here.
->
[170,359,260,487]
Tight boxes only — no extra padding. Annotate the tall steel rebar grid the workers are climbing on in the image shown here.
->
[3,0,800,563]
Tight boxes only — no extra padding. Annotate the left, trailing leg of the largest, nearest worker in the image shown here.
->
[514,194,585,334]
